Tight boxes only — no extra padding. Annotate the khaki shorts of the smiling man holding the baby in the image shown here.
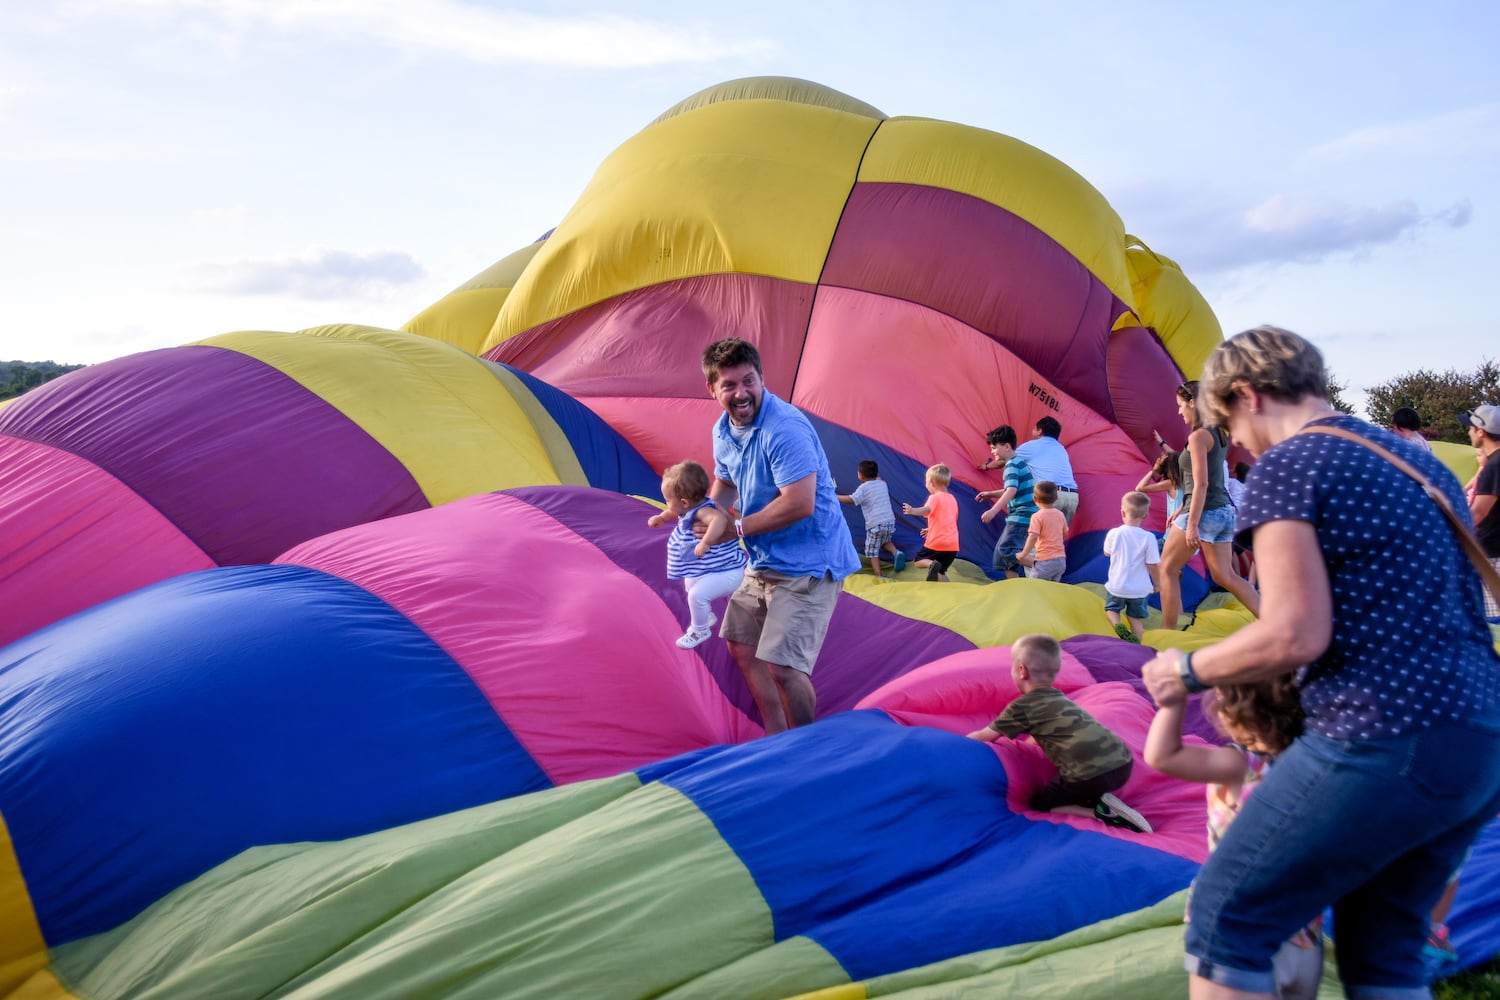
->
[719,570,843,673]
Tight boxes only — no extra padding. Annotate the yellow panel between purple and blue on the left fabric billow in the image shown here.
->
[200,325,563,507]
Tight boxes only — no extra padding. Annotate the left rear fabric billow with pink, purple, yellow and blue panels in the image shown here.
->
[0,327,659,643]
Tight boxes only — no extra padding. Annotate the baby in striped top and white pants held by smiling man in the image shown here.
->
[647,462,747,649]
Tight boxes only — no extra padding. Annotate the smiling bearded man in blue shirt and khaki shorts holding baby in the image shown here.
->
[704,337,860,735]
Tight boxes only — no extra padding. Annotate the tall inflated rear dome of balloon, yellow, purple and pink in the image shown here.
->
[408,78,1221,578]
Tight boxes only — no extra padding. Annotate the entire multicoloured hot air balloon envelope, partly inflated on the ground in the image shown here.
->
[0,78,1500,1000]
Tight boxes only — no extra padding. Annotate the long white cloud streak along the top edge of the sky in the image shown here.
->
[70,0,774,69]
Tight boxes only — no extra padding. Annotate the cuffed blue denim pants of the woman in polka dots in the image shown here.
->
[1185,720,1500,1000]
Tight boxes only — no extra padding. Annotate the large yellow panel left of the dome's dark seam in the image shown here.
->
[485,100,878,351]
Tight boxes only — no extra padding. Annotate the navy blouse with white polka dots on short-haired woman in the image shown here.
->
[1236,415,1500,739]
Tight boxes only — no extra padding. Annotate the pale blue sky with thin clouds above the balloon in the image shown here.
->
[0,0,1500,410]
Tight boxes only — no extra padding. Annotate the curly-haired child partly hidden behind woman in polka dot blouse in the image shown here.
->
[1146,676,1323,1000]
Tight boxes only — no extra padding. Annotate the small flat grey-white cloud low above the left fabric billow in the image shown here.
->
[191,247,426,300]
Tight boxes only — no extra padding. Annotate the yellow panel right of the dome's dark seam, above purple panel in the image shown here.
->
[860,118,1131,303]
